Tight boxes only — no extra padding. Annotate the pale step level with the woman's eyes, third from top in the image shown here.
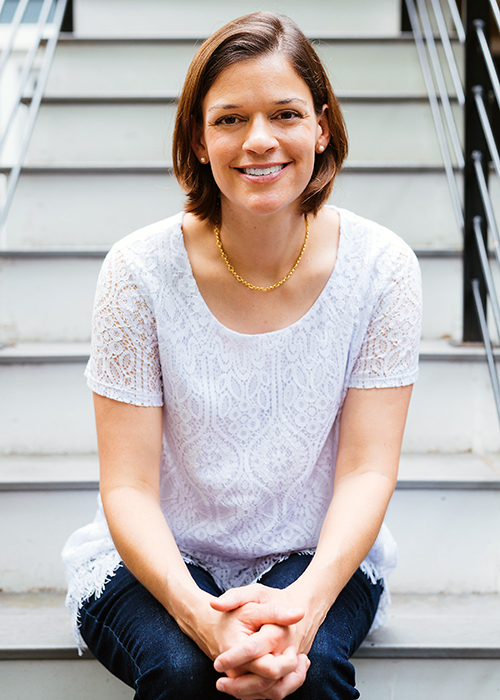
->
[13,94,462,165]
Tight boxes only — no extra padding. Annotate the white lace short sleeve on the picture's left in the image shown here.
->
[85,245,163,406]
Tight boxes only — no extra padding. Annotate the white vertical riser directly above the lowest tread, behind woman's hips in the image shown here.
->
[0,489,500,594]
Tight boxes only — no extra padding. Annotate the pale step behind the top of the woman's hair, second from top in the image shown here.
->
[46,35,463,96]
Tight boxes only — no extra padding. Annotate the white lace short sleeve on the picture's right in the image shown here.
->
[348,244,422,389]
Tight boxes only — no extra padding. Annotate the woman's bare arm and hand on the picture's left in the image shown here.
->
[94,394,307,697]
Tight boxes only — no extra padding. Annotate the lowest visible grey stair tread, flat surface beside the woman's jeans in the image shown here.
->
[0,593,500,659]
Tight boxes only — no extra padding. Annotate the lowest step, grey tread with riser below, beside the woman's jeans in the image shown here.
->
[0,594,500,700]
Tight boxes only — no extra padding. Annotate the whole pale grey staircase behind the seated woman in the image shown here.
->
[0,0,500,700]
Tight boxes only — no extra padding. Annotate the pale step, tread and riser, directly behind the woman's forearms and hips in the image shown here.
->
[0,453,500,594]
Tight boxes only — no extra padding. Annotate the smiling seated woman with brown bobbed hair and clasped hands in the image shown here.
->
[64,13,420,700]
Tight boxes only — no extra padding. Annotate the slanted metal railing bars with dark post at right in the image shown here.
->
[406,0,500,420]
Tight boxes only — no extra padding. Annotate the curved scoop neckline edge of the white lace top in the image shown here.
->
[179,204,346,338]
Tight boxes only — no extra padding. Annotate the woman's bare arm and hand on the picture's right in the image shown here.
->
[212,386,412,697]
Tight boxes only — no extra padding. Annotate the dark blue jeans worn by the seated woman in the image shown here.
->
[80,554,382,700]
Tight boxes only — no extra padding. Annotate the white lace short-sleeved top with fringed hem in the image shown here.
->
[63,210,421,642]
